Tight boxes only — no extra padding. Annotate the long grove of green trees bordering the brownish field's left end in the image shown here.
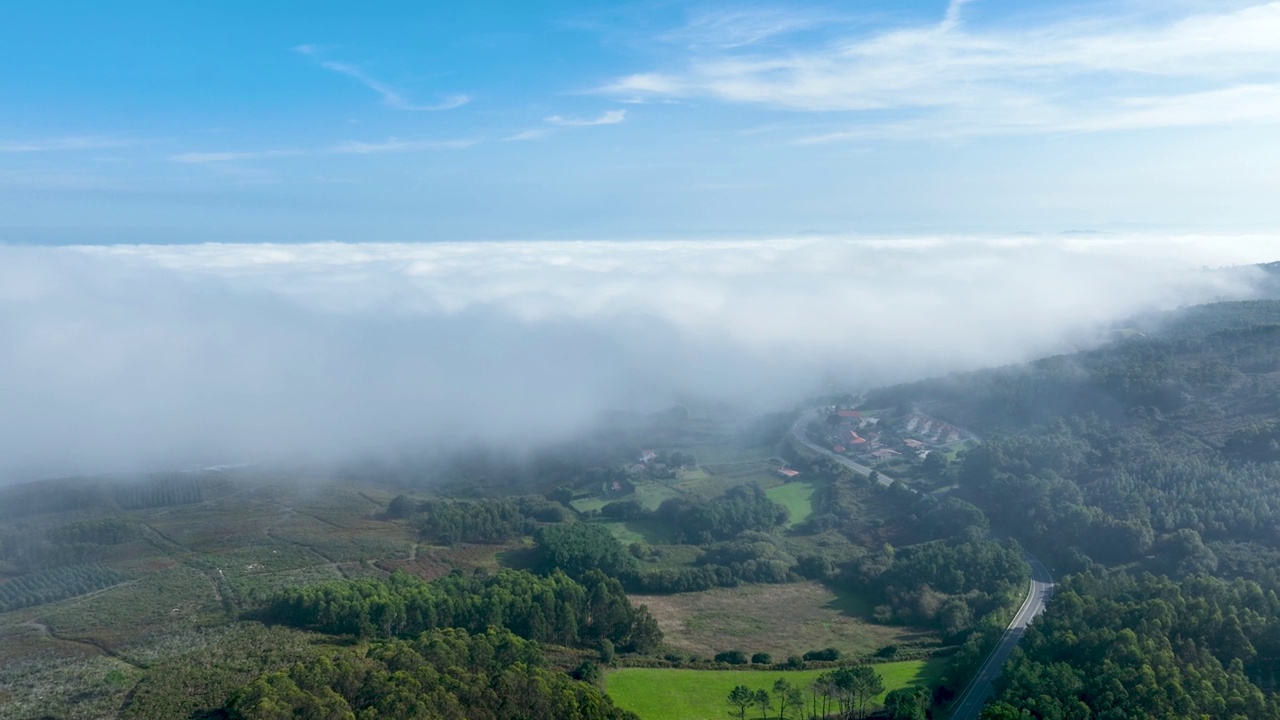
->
[264,570,662,652]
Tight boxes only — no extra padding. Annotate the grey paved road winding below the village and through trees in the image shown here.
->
[791,409,1053,720]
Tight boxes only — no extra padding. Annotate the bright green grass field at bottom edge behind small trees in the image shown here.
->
[607,660,946,720]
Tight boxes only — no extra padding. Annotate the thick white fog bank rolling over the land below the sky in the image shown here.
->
[0,236,1274,482]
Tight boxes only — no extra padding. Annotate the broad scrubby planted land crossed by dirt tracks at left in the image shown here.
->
[0,477,414,720]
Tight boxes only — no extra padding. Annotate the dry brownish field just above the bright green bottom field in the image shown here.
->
[631,583,938,660]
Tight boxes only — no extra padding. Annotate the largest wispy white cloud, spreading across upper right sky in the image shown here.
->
[602,0,1280,141]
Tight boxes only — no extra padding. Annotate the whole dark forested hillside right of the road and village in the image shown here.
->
[867,301,1280,719]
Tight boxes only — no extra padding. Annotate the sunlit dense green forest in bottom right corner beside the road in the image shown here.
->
[986,571,1280,720]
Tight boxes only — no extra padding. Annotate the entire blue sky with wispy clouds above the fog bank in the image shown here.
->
[0,0,1280,243]
